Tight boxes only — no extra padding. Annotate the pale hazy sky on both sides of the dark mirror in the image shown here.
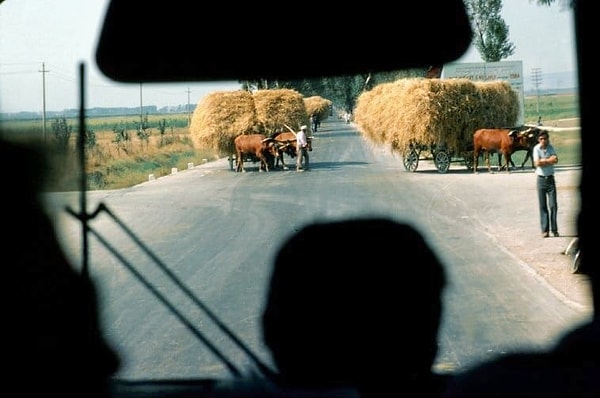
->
[0,0,577,113]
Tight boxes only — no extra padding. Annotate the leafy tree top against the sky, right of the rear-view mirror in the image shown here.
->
[465,0,516,62]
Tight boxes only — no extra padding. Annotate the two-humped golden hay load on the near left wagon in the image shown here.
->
[190,89,308,169]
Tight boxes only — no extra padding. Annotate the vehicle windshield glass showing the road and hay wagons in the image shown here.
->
[0,1,592,394]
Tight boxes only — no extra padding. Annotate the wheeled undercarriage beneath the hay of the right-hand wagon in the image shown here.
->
[402,140,473,173]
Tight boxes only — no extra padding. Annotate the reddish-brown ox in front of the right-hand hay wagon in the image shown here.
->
[473,129,527,173]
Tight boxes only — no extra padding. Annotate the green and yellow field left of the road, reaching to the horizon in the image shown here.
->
[3,114,215,191]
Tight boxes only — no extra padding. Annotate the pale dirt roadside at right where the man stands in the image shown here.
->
[396,118,592,311]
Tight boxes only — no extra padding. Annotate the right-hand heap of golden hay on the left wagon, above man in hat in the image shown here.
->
[252,89,309,136]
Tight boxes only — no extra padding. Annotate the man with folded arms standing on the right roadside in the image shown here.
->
[533,130,559,238]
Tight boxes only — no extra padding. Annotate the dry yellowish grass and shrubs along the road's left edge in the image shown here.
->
[4,123,216,192]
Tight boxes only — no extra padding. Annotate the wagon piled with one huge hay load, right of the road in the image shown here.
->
[354,78,519,173]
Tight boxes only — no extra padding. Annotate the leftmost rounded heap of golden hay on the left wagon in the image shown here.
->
[190,90,258,158]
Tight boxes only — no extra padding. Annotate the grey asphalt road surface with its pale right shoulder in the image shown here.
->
[43,120,592,379]
